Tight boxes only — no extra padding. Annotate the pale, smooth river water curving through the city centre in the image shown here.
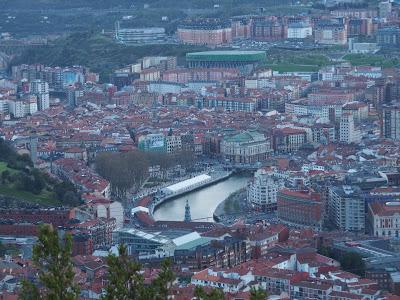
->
[154,175,250,221]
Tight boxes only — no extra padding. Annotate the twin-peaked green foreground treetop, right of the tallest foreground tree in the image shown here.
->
[103,245,175,300]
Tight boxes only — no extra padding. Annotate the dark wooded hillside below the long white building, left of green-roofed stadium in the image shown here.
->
[12,32,205,82]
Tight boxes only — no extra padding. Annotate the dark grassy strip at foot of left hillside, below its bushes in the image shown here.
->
[0,185,61,205]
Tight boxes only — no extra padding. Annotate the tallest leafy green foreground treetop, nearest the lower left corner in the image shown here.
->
[20,225,79,300]
